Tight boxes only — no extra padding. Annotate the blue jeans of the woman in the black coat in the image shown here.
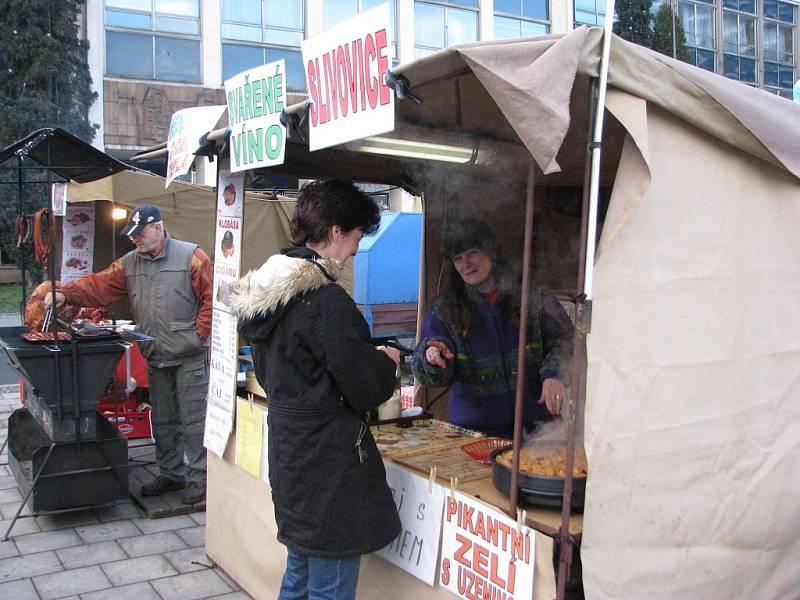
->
[278,550,361,600]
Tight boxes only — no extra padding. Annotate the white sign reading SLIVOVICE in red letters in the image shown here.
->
[302,3,394,151]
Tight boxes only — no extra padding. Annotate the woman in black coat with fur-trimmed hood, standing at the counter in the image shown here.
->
[230,179,400,600]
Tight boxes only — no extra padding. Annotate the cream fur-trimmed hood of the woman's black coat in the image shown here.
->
[227,248,342,340]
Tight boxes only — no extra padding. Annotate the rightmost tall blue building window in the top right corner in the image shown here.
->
[763,0,797,99]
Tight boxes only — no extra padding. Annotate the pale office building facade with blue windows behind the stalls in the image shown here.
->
[83,0,798,165]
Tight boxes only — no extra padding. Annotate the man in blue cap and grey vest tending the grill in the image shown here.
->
[46,204,212,504]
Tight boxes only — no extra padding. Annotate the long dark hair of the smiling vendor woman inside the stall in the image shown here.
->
[441,219,519,337]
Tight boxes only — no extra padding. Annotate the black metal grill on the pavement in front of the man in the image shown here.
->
[0,327,128,512]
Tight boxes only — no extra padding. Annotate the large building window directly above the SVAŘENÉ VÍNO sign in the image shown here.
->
[220,0,306,92]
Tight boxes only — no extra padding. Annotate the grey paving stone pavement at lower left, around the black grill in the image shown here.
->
[0,385,250,600]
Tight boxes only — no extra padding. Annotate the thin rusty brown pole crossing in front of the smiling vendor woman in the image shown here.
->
[508,158,536,519]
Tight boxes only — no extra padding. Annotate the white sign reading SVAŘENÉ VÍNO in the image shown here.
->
[225,59,286,172]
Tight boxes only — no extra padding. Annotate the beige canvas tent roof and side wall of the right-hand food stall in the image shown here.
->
[260,28,800,600]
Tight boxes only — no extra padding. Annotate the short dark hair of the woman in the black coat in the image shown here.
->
[290,178,381,246]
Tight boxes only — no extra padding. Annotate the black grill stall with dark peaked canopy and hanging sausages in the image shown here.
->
[0,129,134,540]
